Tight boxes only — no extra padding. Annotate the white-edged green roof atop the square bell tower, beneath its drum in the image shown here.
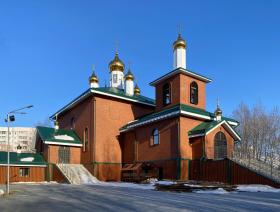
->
[150,68,212,86]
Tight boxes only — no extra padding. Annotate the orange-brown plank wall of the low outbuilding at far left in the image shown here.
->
[0,166,46,184]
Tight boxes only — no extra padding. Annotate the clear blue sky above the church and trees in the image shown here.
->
[0,0,280,126]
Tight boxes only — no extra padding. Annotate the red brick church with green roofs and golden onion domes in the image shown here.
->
[36,34,240,181]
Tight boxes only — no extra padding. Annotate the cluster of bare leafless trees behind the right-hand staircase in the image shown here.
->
[233,103,280,170]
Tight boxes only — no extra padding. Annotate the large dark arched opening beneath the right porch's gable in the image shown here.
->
[214,132,227,159]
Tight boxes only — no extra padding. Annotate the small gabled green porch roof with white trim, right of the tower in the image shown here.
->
[188,120,241,141]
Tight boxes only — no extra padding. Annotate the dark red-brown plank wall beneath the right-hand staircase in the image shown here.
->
[190,159,280,188]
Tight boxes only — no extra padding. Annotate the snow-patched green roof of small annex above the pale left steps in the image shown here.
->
[37,126,82,146]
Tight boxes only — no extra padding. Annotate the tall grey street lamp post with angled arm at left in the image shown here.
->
[5,105,33,194]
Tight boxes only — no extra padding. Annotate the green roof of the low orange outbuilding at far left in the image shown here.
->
[0,152,47,166]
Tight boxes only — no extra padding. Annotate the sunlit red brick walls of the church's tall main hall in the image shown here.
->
[59,95,154,180]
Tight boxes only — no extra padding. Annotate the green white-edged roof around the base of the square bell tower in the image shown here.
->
[120,104,238,131]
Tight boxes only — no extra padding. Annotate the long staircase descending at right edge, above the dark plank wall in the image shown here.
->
[231,157,280,183]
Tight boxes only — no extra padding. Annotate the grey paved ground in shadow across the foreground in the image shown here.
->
[0,184,280,212]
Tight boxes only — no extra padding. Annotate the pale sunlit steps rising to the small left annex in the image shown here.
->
[56,163,99,185]
